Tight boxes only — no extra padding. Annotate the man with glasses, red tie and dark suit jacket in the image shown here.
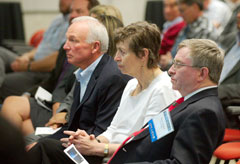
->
[109,39,225,164]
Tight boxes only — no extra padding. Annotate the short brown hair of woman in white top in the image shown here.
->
[114,21,161,68]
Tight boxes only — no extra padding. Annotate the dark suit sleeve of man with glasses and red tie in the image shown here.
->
[125,110,221,164]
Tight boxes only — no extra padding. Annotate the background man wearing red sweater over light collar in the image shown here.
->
[159,0,185,70]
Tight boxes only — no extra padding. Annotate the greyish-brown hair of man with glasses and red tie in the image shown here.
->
[178,39,224,84]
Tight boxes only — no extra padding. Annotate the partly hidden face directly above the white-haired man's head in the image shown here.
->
[70,0,89,22]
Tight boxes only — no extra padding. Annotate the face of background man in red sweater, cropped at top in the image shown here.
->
[163,0,180,21]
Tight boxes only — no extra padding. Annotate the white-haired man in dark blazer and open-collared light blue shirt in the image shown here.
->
[29,16,130,164]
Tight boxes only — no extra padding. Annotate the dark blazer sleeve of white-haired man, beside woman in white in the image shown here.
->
[88,75,127,136]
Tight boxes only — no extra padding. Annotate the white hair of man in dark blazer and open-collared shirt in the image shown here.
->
[72,16,109,53]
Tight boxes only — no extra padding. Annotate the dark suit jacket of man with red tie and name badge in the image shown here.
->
[111,88,225,164]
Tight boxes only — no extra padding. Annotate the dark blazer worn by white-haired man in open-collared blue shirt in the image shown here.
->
[50,54,131,139]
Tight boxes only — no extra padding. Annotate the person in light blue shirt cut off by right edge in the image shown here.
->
[218,11,240,128]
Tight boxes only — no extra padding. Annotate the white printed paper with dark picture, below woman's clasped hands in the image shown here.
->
[64,144,89,164]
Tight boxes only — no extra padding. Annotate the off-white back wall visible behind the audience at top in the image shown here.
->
[0,0,148,41]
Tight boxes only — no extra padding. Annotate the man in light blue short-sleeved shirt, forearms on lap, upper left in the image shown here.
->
[0,0,72,103]
